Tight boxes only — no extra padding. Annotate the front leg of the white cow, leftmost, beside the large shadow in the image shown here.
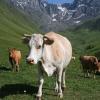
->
[36,64,44,100]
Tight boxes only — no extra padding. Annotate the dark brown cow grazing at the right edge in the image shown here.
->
[79,56,100,78]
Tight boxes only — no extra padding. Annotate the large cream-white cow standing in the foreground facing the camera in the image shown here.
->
[23,32,72,99]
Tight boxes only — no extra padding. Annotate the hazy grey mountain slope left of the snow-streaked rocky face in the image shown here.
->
[8,0,61,32]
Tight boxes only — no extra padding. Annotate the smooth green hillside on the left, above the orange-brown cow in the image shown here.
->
[0,0,39,62]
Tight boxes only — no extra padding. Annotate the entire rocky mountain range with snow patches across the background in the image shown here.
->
[8,0,100,32]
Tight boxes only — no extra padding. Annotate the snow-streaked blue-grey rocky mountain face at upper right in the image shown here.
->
[45,0,100,26]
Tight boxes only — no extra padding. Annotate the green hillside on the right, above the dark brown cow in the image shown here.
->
[72,18,100,58]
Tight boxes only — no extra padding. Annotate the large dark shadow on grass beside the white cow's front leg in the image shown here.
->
[0,84,38,98]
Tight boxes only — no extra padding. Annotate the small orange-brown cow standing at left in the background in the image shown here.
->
[9,48,21,71]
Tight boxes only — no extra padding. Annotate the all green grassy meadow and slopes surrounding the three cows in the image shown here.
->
[0,0,100,100]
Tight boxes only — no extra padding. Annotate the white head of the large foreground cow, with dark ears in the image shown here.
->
[23,34,54,64]
